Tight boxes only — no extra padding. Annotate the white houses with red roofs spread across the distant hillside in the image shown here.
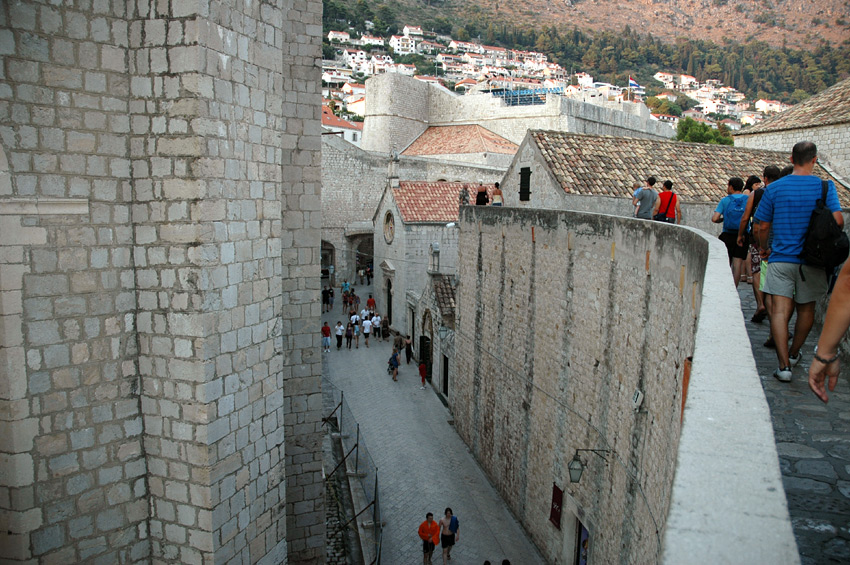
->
[322,23,790,140]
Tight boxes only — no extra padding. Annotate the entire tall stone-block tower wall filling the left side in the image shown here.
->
[0,1,324,563]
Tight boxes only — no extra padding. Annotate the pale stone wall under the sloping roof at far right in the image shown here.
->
[735,123,850,180]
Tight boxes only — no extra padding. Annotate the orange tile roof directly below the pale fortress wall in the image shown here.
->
[402,125,519,155]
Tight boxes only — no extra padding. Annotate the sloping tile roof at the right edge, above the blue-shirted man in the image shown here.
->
[735,79,850,137]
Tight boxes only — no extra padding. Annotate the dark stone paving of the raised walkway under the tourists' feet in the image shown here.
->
[738,283,850,565]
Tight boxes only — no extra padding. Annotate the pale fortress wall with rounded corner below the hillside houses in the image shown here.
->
[361,73,674,153]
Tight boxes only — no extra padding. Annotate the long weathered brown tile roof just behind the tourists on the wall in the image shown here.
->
[529,130,850,206]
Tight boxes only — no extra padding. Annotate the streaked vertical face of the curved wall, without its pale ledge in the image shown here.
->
[458,207,707,563]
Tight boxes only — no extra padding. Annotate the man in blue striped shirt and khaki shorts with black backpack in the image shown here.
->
[754,141,844,382]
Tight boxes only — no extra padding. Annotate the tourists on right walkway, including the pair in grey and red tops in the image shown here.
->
[632,141,850,402]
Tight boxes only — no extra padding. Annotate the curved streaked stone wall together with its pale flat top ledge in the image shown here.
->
[451,207,797,563]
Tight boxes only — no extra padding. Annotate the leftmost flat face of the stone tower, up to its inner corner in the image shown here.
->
[0,2,146,563]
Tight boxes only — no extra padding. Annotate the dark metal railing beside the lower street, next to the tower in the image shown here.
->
[322,377,383,565]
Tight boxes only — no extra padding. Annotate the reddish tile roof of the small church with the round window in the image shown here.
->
[392,181,495,224]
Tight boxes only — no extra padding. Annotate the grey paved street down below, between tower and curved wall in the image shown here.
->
[322,286,543,565]
